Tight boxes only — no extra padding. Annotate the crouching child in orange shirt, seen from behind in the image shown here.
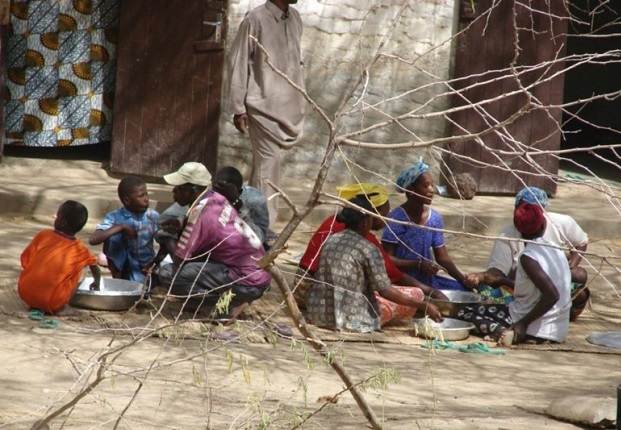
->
[17,200,101,314]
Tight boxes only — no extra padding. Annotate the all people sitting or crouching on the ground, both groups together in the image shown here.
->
[18,160,590,344]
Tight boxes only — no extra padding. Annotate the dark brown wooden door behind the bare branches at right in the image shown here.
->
[443,0,567,195]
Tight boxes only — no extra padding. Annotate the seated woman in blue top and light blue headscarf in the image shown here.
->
[382,160,474,290]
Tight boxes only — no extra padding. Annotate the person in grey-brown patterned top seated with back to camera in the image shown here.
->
[306,196,442,333]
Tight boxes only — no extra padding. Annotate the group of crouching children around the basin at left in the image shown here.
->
[18,162,271,319]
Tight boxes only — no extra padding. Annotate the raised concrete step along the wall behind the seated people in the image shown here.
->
[0,157,621,238]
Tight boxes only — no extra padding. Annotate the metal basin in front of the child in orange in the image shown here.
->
[69,278,144,311]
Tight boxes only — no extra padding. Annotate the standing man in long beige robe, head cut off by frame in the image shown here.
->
[229,0,306,224]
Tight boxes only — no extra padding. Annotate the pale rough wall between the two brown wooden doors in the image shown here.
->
[219,0,455,188]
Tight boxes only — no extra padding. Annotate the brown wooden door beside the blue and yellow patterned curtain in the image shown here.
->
[111,0,226,177]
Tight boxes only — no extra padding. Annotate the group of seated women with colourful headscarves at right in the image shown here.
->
[294,161,590,345]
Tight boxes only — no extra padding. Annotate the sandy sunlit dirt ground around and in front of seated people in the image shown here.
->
[0,156,621,430]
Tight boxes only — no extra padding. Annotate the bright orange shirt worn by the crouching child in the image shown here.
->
[17,230,97,313]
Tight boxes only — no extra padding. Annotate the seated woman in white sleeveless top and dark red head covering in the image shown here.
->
[458,203,571,346]
